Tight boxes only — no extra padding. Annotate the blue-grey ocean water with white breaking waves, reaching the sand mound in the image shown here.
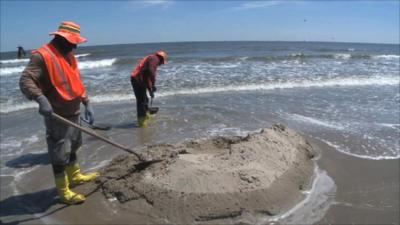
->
[0,42,400,223]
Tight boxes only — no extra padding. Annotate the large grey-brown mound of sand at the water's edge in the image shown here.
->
[98,125,313,224]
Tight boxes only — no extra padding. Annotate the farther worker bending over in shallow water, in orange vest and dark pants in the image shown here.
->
[131,51,168,127]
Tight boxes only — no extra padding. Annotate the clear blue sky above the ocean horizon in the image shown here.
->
[0,0,400,52]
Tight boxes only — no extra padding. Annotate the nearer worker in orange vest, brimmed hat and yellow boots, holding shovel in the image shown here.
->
[19,22,99,204]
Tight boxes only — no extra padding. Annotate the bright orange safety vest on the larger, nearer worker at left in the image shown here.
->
[33,44,86,101]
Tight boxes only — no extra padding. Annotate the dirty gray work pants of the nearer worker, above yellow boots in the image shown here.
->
[45,115,82,168]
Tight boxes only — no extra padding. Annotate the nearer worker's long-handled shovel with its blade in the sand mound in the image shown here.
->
[51,113,162,164]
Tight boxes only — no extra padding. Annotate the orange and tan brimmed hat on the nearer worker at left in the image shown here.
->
[50,21,87,44]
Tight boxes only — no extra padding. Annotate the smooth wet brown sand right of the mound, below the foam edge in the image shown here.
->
[307,138,400,224]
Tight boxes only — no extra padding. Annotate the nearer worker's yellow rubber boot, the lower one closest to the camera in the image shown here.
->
[55,175,86,205]
